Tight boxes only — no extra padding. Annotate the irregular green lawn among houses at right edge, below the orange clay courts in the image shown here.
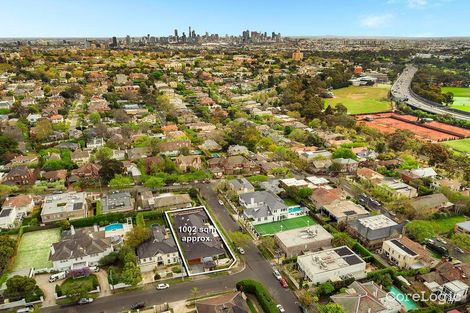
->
[406,216,467,242]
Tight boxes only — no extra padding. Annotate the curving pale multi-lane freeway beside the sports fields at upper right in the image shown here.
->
[391,65,470,120]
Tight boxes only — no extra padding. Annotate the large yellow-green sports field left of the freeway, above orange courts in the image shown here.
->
[325,85,391,114]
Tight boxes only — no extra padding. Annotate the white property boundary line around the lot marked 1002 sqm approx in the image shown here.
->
[165,205,237,277]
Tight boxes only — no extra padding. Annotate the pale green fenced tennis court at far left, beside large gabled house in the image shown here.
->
[14,228,60,270]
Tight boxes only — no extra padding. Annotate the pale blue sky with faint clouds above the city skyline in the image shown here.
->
[0,0,470,37]
